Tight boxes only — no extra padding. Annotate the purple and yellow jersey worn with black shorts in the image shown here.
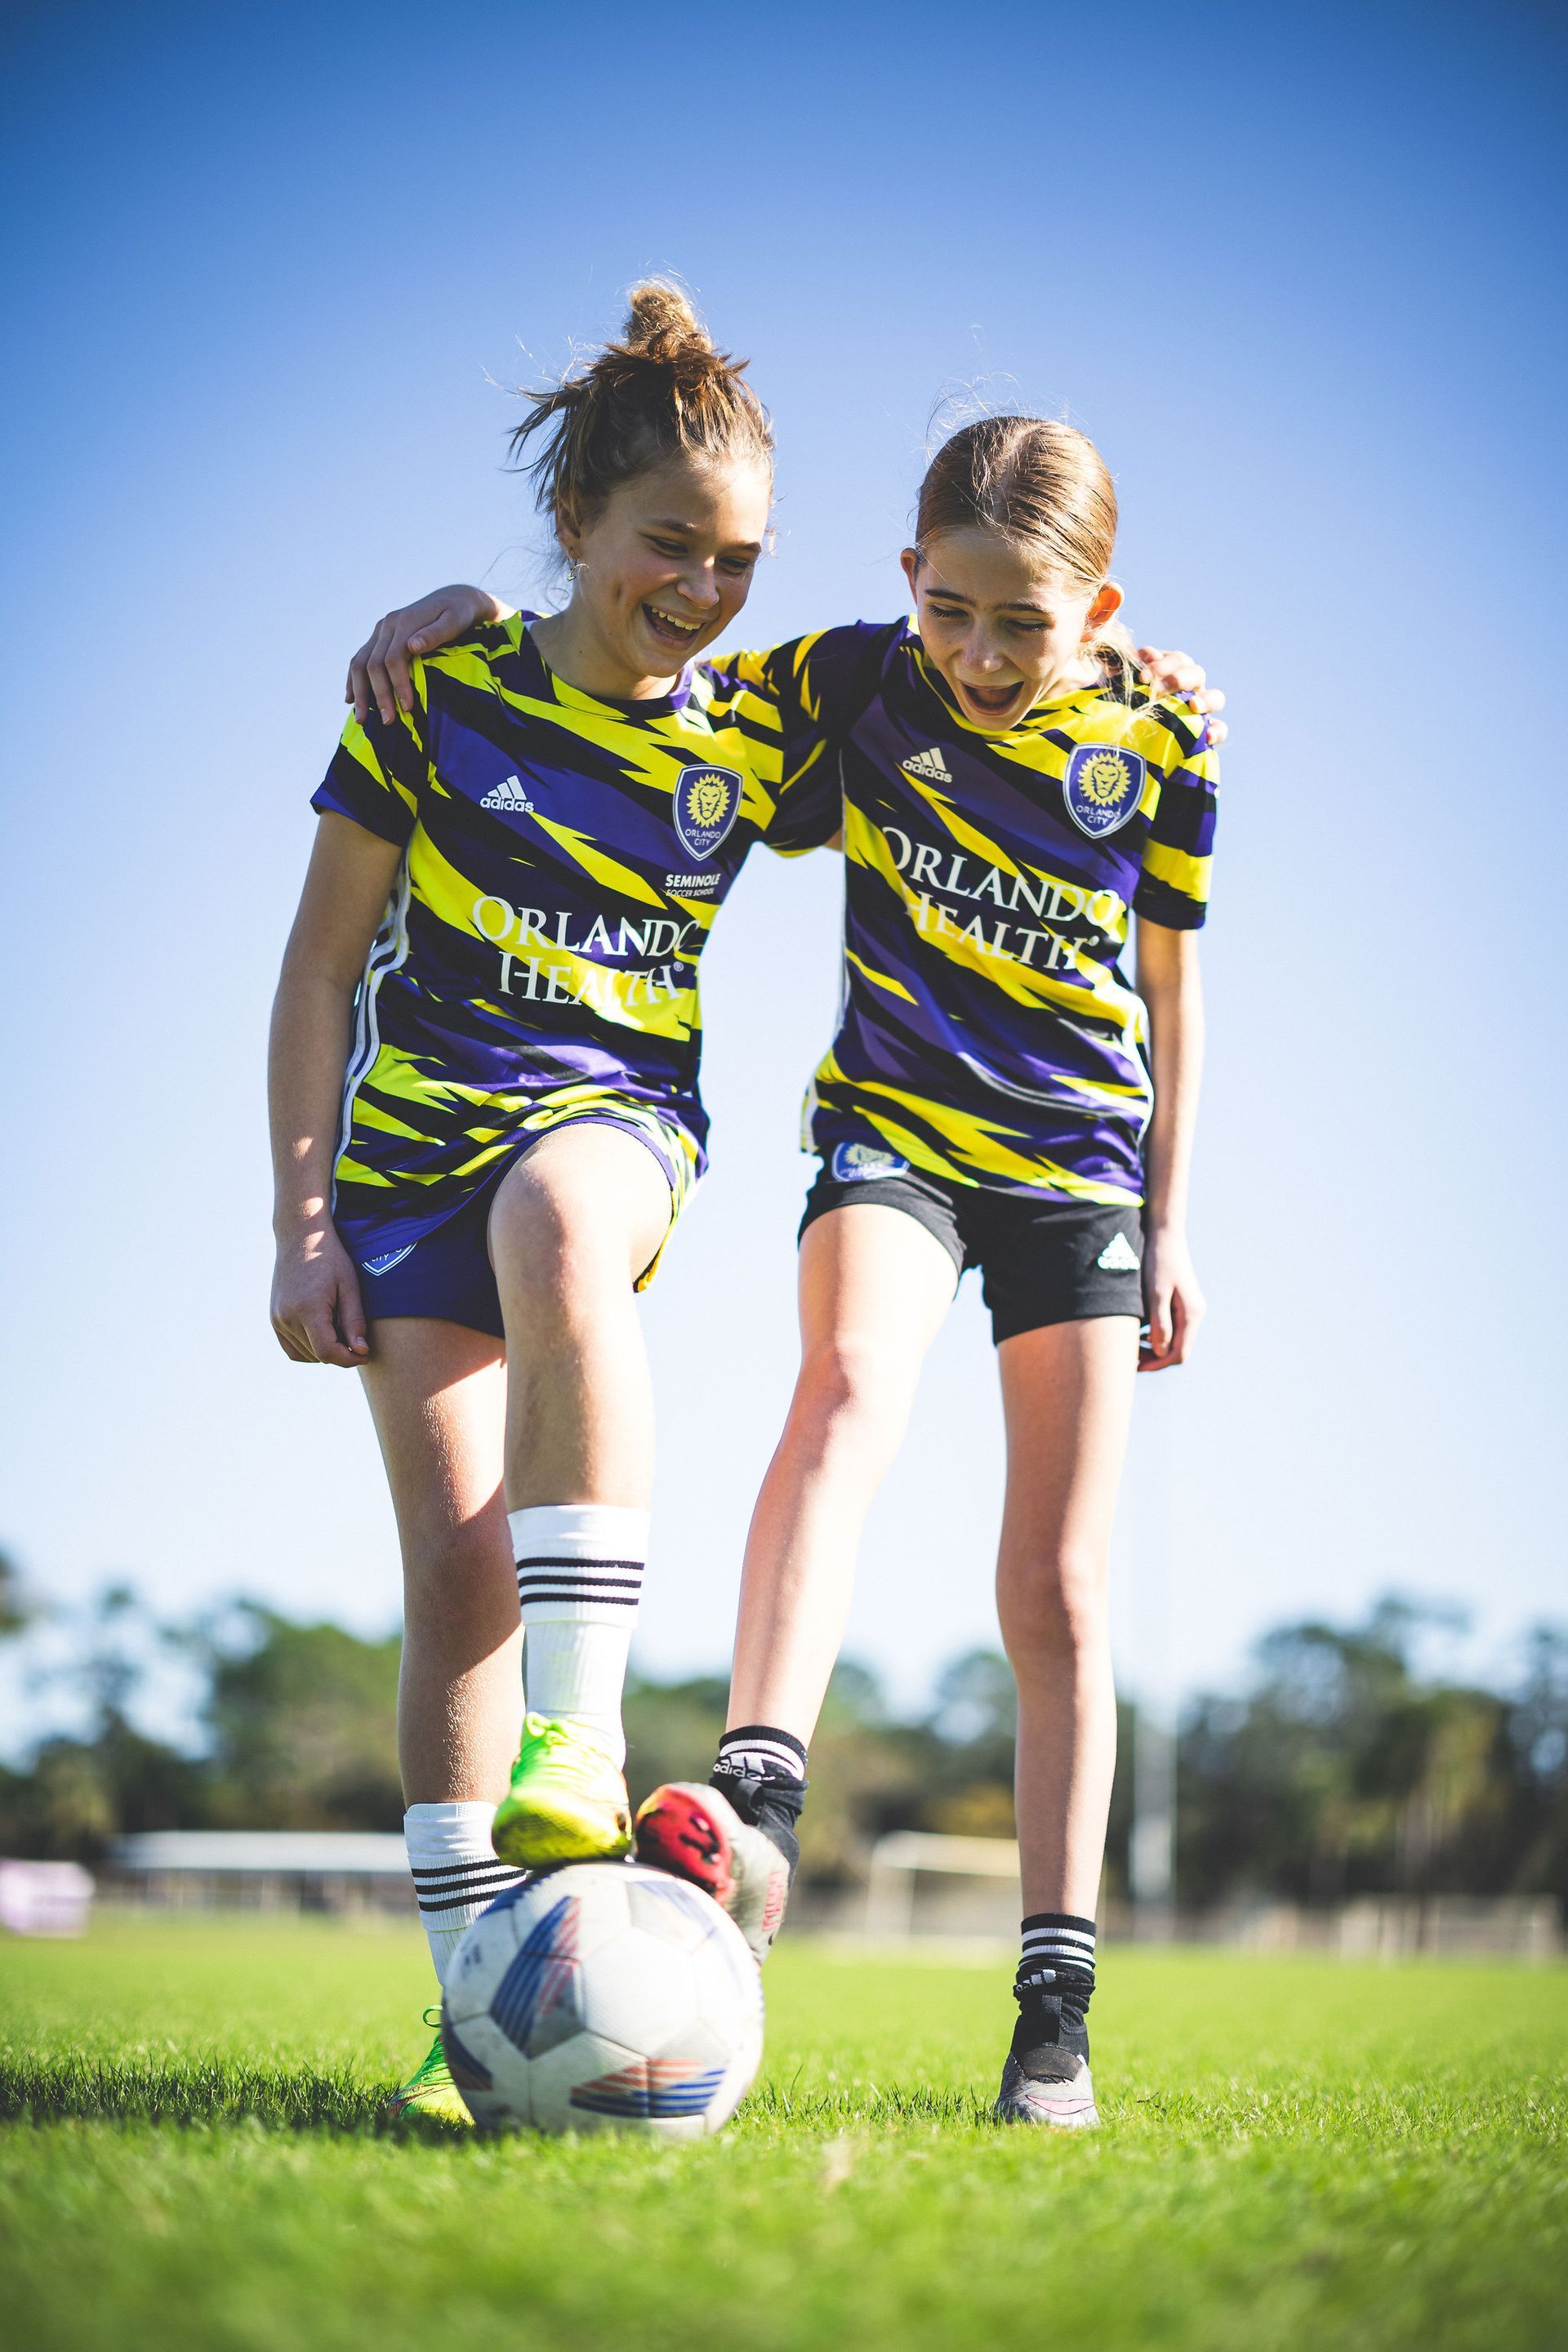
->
[738,621,1218,1202]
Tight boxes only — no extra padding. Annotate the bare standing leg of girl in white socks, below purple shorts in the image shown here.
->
[362,1317,522,1804]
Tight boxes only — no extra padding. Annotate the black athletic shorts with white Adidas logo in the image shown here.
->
[800,1169,1143,1345]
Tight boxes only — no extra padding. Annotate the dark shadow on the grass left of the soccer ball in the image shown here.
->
[0,2056,466,2140]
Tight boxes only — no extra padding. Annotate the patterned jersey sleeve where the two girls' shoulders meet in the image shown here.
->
[710,621,896,856]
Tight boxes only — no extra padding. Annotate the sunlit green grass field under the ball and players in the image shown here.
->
[0,1919,1568,2352]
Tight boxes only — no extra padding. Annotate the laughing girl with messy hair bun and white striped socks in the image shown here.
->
[270,284,840,2119]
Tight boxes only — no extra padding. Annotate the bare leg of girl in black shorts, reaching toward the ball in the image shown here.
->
[728,1202,957,1740]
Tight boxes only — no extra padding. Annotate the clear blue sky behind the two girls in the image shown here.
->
[0,5,1566,1749]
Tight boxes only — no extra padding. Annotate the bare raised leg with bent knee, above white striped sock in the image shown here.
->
[489,1127,670,1505]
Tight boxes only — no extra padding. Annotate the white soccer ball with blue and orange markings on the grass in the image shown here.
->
[442,1863,762,2140]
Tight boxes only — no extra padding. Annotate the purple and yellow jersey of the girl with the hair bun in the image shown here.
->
[313,614,840,1261]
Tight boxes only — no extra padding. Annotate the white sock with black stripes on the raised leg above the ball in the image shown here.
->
[508,1503,648,1766]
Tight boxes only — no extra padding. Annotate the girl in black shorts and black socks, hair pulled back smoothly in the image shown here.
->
[297,284,1223,2127]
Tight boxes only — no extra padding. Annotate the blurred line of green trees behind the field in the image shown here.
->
[0,1561,1568,1910]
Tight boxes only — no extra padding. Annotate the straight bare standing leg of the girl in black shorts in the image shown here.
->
[997,1315,1138,1919]
